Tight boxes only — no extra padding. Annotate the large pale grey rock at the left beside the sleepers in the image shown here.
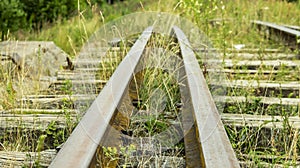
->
[0,41,68,77]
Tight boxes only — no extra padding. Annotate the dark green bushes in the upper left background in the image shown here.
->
[0,0,103,37]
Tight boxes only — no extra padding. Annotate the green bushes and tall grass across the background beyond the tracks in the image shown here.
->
[0,0,300,56]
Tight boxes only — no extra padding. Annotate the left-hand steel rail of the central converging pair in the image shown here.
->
[50,27,152,168]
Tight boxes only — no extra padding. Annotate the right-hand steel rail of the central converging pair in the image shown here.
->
[173,26,239,167]
